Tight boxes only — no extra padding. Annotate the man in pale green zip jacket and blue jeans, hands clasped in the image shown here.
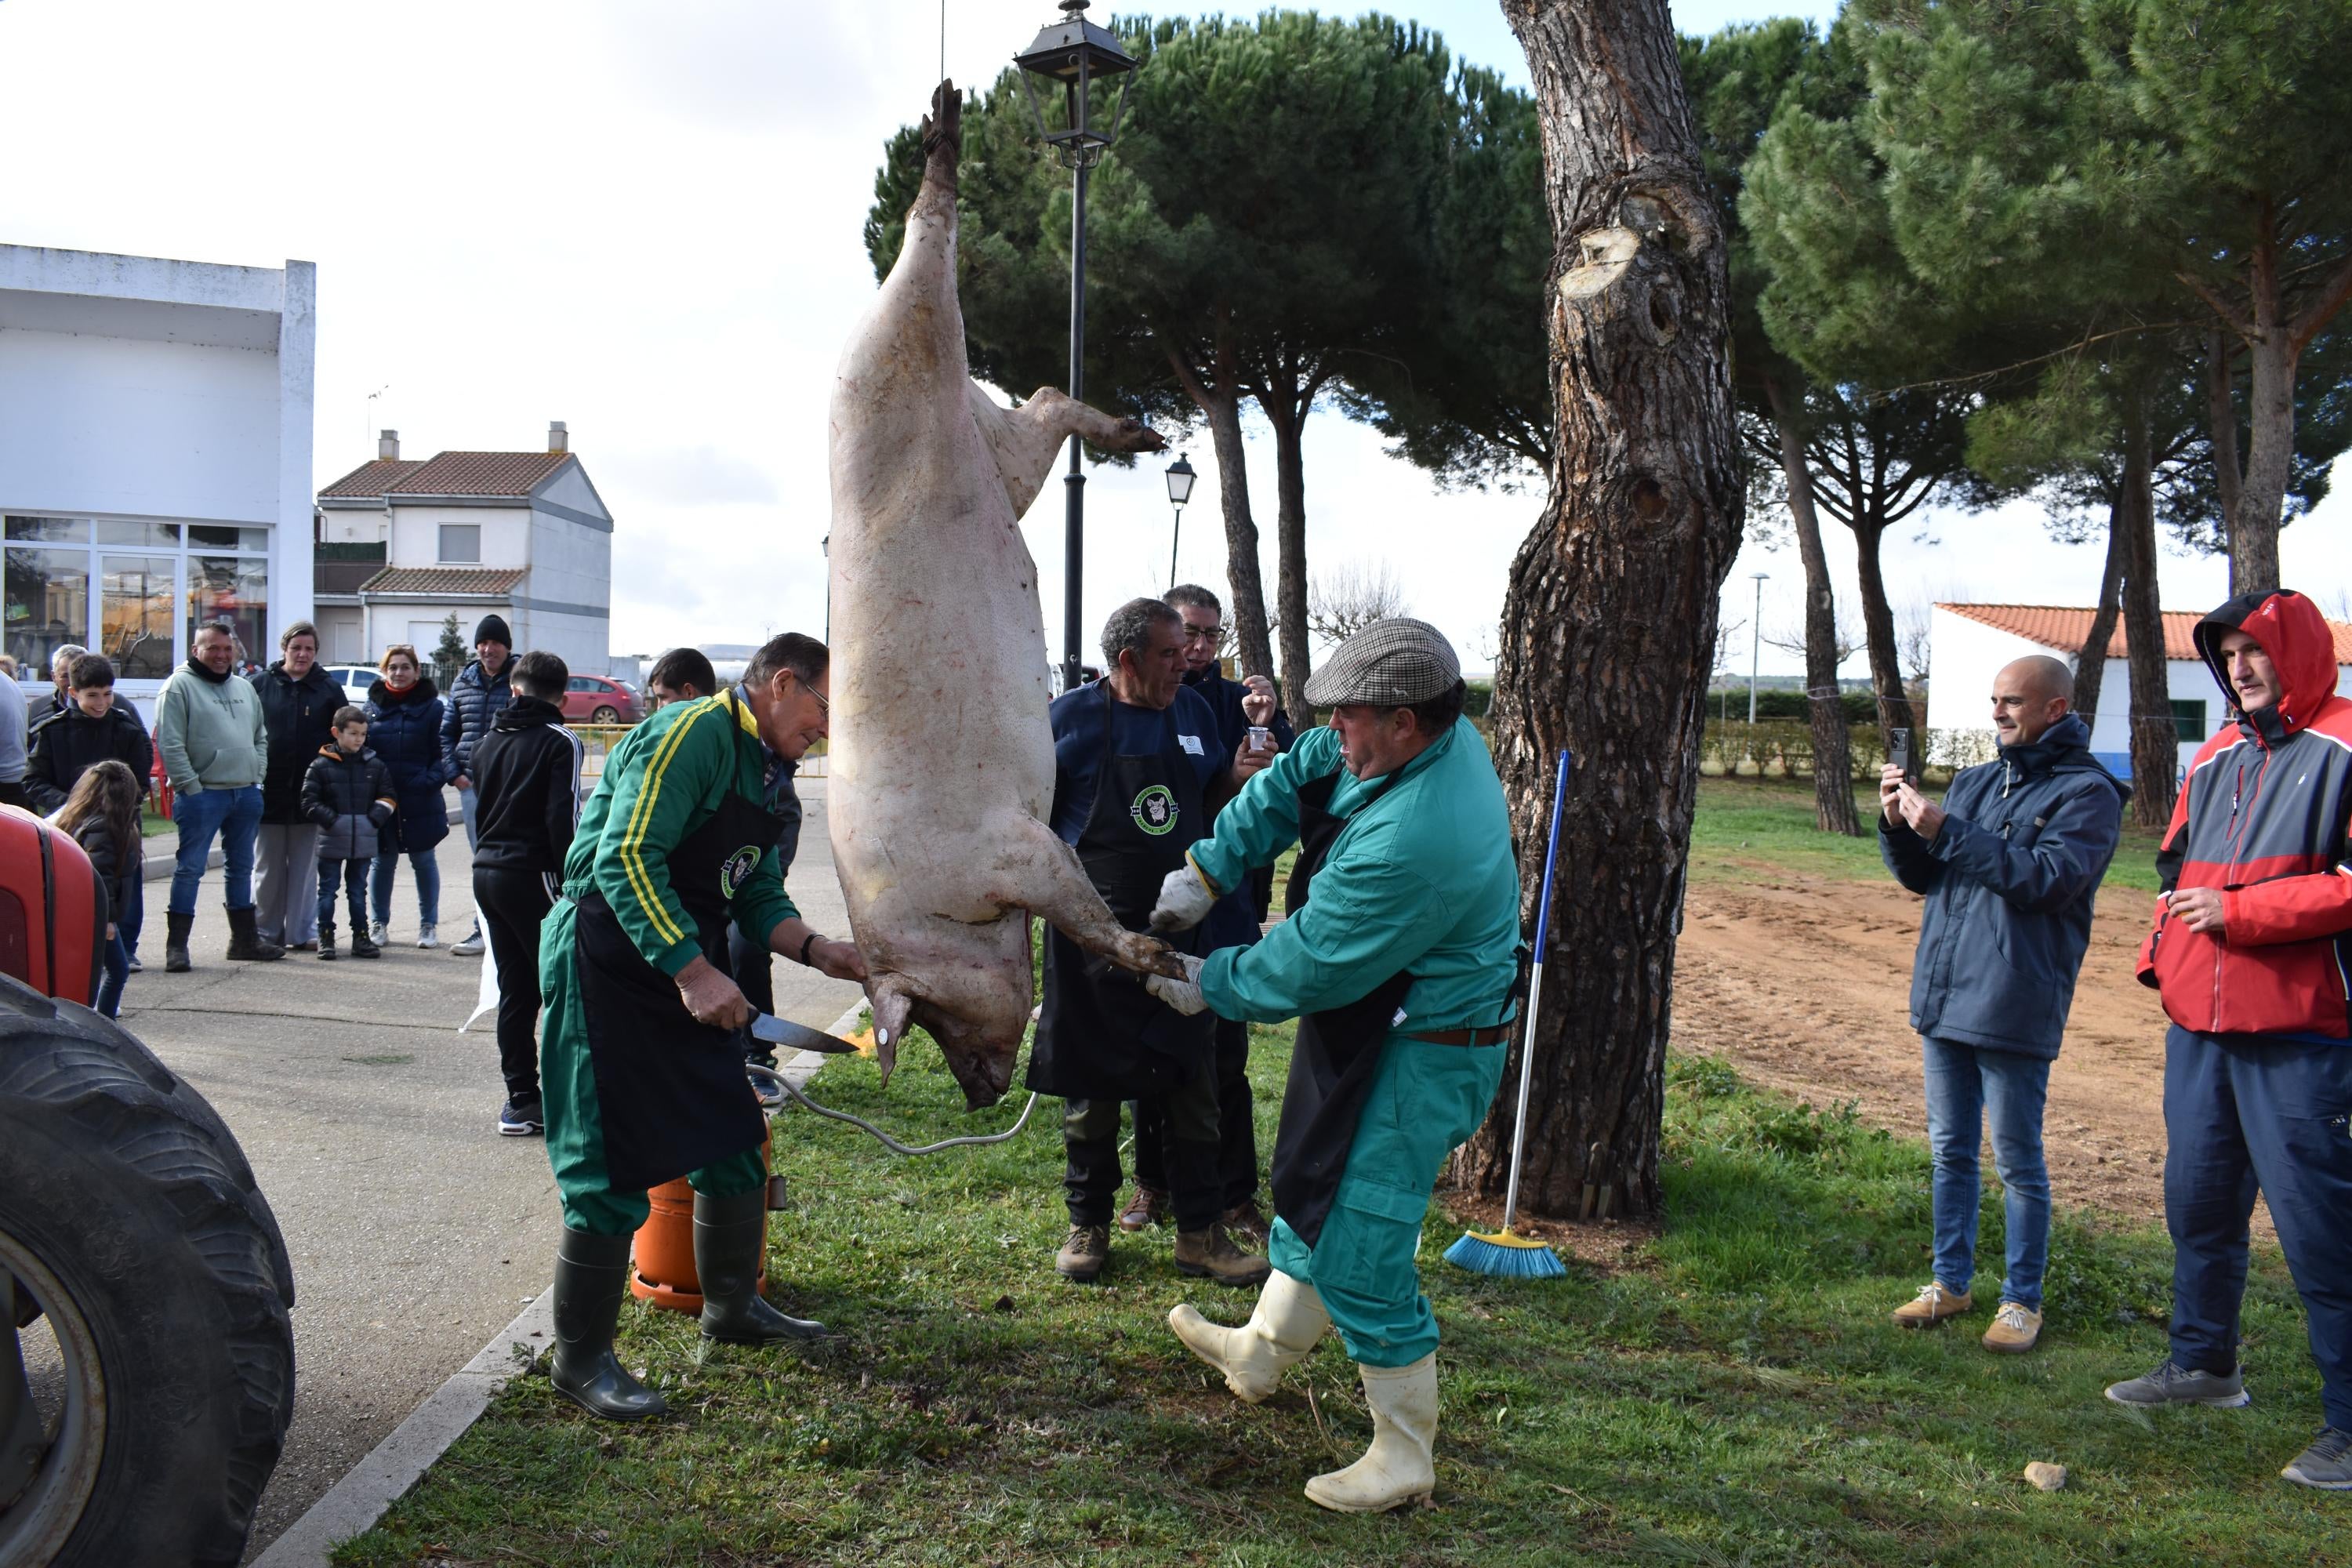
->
[155,626,285,973]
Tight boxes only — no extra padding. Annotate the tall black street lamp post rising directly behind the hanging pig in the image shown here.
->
[1014,0,1136,691]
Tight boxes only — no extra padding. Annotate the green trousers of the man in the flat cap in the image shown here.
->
[1270,1034,1508,1366]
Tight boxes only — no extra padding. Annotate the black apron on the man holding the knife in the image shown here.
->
[574,694,786,1192]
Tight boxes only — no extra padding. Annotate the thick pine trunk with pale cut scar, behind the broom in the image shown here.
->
[1451,0,1743,1215]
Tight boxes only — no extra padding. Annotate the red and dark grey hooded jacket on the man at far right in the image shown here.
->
[2140,588,2352,1039]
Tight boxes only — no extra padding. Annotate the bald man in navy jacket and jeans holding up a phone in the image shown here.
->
[1879,659,2129,1354]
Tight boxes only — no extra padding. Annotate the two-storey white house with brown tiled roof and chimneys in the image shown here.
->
[315,421,612,673]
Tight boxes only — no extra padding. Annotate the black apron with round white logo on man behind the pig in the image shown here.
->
[1028,682,1216,1100]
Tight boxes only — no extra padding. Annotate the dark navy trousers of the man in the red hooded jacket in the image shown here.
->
[2164,1025,2352,1432]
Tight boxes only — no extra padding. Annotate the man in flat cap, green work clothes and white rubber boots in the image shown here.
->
[1145,619,1519,1514]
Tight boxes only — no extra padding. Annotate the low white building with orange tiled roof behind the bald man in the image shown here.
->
[1926,604,2352,779]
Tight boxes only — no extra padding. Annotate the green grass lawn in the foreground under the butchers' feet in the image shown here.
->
[334,1029,2352,1568]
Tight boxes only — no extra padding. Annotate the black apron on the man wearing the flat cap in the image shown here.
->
[1275,769,1414,1248]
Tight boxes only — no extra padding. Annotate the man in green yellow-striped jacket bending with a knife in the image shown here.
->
[539,633,866,1420]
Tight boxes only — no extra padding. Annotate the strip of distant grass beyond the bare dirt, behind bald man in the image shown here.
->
[1691,779,2164,893]
